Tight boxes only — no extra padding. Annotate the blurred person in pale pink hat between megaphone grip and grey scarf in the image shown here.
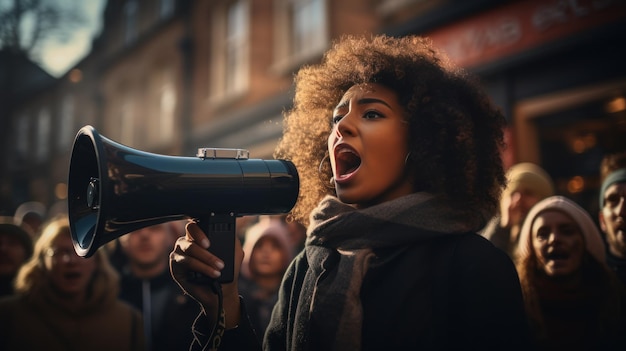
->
[239,216,293,342]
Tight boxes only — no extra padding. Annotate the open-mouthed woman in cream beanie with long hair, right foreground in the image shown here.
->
[515,196,626,350]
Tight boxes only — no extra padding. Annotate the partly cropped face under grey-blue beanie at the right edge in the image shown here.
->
[600,183,626,258]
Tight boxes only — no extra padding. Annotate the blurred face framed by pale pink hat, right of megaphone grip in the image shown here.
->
[250,236,287,276]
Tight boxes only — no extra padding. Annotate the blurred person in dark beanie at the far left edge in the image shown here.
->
[0,217,33,296]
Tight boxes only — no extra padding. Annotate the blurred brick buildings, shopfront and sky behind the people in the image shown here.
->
[0,0,626,220]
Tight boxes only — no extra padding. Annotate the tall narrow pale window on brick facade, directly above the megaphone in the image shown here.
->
[210,0,249,103]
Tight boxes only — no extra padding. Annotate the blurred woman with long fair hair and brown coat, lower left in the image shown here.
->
[0,216,144,351]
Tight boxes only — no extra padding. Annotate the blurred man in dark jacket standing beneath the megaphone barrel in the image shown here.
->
[118,221,195,351]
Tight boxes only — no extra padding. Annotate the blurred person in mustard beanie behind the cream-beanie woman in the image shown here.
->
[481,162,554,259]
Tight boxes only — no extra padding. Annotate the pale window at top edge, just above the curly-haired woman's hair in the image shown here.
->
[276,0,329,70]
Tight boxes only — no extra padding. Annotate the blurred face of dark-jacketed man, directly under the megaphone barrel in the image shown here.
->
[119,223,174,273]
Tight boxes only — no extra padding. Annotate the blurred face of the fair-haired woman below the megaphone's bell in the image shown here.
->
[44,232,97,298]
